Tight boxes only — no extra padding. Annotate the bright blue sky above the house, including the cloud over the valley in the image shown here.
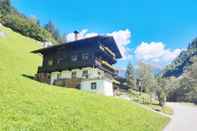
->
[12,0,197,67]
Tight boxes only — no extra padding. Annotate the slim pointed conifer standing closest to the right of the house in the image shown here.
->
[125,62,136,89]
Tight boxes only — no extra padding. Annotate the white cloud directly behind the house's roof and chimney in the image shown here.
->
[66,29,131,60]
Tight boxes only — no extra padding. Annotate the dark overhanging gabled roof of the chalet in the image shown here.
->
[32,36,122,58]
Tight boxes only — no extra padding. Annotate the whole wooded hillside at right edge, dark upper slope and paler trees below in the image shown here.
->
[162,38,197,104]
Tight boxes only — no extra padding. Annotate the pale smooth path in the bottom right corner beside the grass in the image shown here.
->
[164,103,197,131]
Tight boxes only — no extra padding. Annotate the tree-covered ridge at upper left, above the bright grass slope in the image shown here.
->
[0,0,57,43]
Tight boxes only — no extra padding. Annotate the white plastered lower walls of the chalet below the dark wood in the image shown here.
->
[50,67,108,96]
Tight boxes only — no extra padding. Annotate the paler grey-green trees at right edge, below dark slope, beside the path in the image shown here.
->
[167,57,197,104]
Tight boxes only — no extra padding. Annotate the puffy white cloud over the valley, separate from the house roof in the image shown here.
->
[135,42,182,68]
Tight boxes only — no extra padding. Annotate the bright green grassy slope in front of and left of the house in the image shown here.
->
[0,27,168,131]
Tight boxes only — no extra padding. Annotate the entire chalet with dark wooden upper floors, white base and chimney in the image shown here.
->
[32,32,121,96]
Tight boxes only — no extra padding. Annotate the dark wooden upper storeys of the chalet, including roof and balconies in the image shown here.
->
[33,36,121,79]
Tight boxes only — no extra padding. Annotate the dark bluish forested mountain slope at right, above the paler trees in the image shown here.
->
[161,38,197,77]
